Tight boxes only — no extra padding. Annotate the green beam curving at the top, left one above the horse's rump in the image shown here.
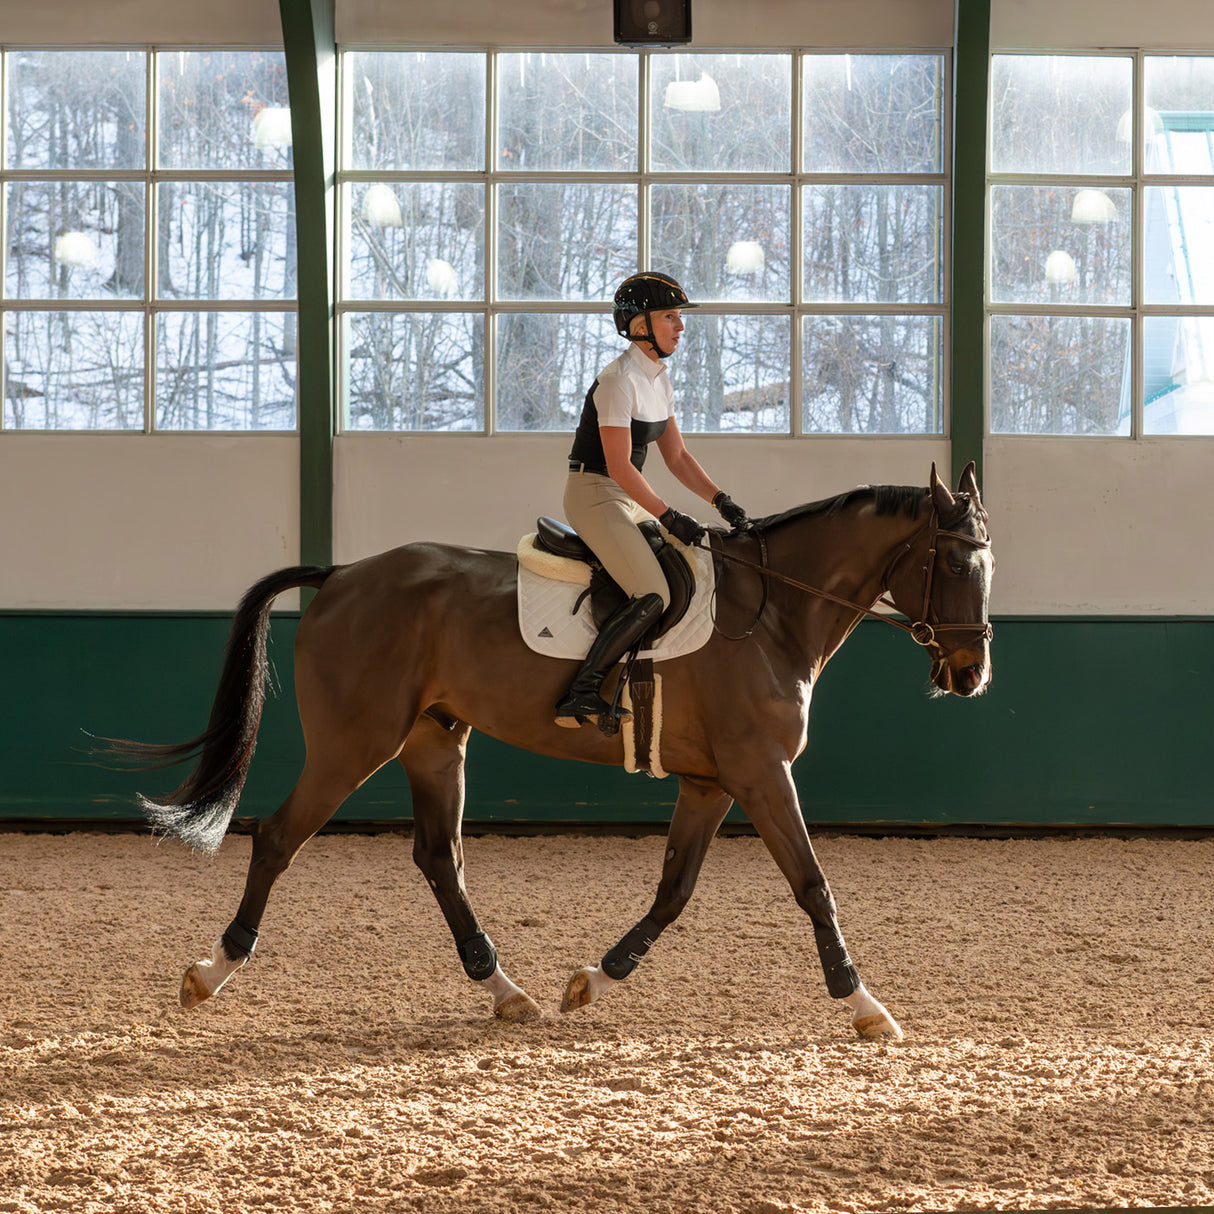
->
[279,0,337,565]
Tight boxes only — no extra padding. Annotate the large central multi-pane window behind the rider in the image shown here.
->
[339,50,948,435]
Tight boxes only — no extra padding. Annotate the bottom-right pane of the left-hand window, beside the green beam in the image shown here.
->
[155,312,296,430]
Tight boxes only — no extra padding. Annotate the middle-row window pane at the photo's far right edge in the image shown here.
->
[1142,186,1214,304]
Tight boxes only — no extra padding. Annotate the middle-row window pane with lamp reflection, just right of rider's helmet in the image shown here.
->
[649,182,792,302]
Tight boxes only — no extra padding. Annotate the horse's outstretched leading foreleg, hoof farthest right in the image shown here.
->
[739,762,902,1040]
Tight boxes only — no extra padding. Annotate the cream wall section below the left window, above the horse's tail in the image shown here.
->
[0,433,299,611]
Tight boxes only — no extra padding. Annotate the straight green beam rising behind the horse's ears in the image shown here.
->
[949,0,991,484]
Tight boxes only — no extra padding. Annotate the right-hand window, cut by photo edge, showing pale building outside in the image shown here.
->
[989,55,1214,436]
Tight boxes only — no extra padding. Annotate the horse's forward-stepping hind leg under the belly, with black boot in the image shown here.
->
[401,714,541,1021]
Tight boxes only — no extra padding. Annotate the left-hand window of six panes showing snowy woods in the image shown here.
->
[0,50,296,431]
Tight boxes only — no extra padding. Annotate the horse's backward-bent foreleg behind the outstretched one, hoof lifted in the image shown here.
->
[561,776,733,1011]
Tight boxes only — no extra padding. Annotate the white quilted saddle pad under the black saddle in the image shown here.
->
[518,532,714,662]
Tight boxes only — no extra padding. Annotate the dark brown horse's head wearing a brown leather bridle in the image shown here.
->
[889,463,994,696]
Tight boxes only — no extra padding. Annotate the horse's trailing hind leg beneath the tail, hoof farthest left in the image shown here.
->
[181,761,362,1008]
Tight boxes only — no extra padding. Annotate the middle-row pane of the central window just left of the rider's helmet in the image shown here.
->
[498,182,636,300]
